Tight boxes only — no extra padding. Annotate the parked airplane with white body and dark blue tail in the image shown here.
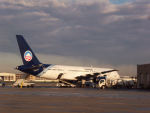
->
[16,35,120,86]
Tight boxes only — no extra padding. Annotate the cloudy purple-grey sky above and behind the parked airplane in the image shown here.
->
[0,0,150,76]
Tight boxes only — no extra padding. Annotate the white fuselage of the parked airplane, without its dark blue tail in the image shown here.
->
[38,65,120,80]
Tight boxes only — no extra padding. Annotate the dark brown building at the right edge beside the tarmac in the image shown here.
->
[137,64,150,89]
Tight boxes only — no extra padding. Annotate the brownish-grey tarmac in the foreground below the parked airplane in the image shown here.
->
[0,88,150,113]
